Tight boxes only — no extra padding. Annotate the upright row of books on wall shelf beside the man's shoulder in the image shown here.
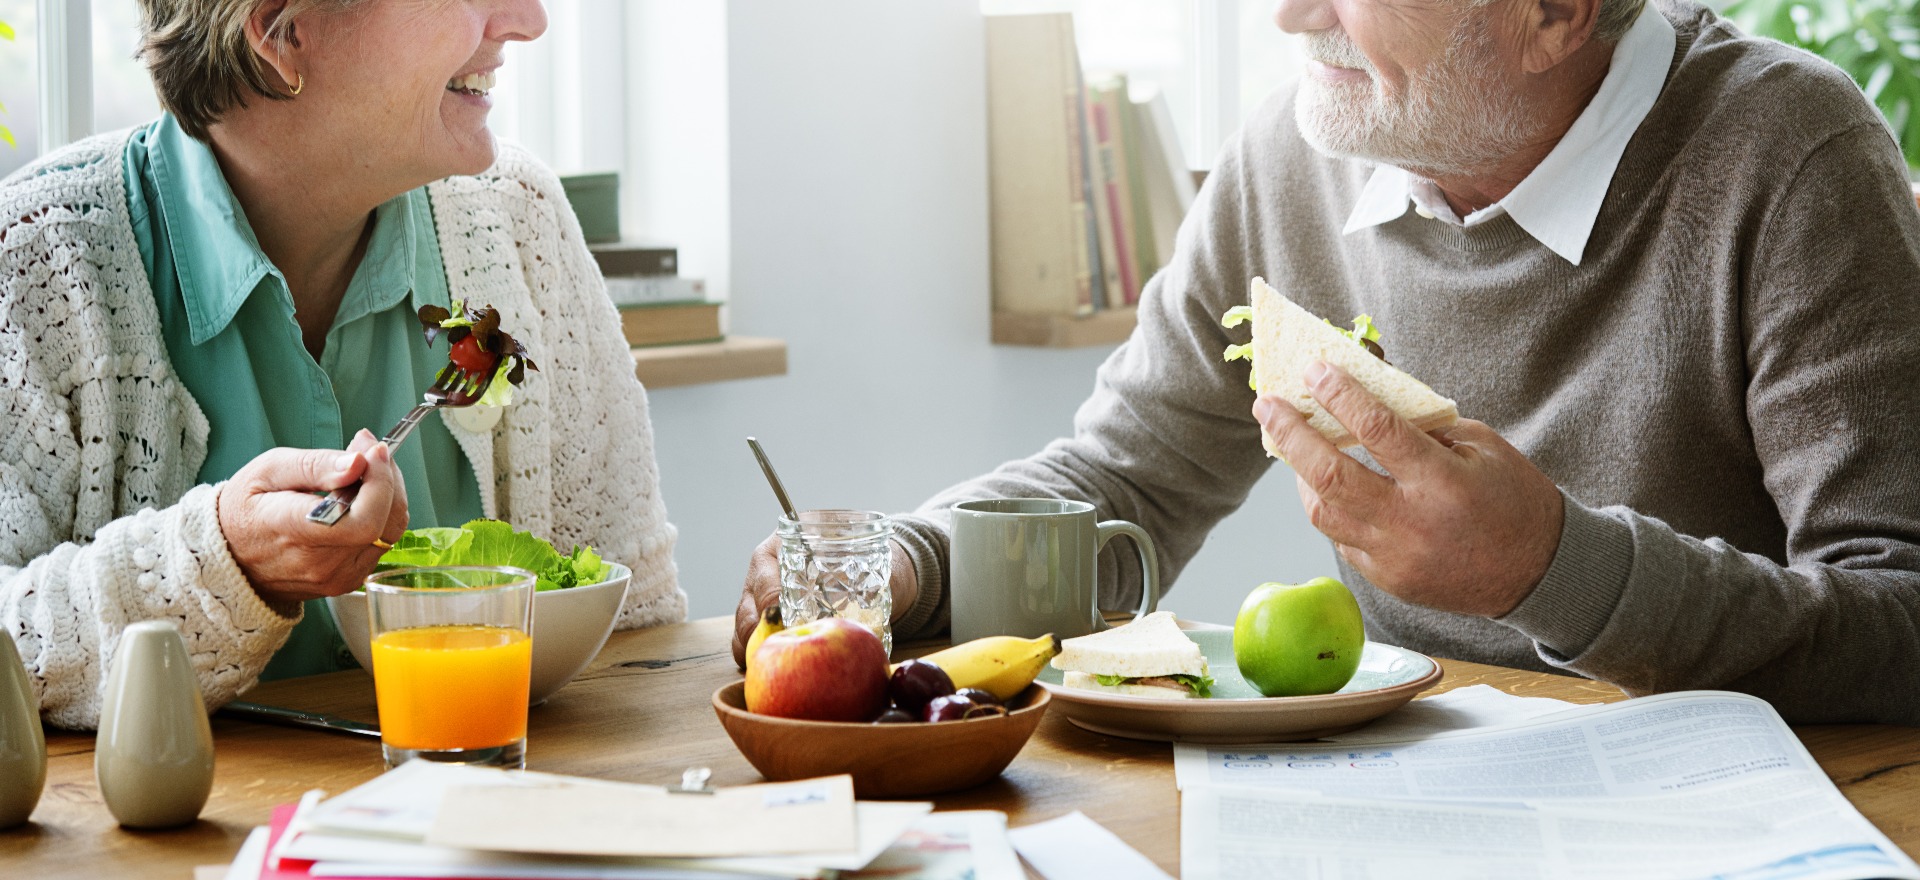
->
[987,13,1194,315]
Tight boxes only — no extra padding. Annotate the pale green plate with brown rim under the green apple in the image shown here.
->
[1039,621,1440,744]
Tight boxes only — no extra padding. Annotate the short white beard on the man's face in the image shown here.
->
[1294,21,1540,177]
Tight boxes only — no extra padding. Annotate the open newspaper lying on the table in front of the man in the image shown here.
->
[1173,692,1920,880]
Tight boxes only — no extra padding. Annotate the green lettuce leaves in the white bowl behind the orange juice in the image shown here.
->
[380,519,612,592]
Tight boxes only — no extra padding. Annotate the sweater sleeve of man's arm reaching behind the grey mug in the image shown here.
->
[895,141,1271,638]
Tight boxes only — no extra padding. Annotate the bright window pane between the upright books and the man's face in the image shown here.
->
[981,0,1302,167]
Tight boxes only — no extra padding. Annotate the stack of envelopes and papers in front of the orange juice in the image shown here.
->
[227,761,1021,880]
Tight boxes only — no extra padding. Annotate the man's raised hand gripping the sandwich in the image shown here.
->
[1254,363,1565,617]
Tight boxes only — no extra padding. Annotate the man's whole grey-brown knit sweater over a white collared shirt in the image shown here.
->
[900,0,1920,724]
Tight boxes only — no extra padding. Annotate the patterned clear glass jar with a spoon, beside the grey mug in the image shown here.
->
[780,511,893,655]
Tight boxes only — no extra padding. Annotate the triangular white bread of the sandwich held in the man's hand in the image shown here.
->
[1248,279,1459,457]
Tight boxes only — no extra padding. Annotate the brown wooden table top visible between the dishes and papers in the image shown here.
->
[0,617,1920,880]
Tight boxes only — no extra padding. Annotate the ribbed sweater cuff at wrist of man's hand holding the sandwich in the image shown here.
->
[1500,492,1634,657]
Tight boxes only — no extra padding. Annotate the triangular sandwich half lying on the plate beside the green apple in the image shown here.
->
[1054,611,1213,699]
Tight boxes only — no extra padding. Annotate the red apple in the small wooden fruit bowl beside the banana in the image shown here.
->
[747,617,887,721]
